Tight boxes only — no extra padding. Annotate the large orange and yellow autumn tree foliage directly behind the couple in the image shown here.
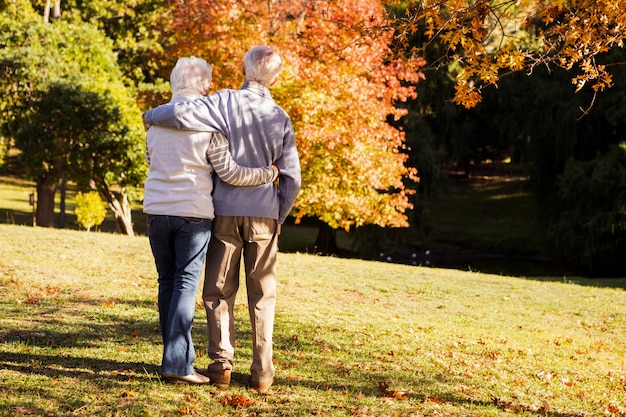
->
[156,0,423,229]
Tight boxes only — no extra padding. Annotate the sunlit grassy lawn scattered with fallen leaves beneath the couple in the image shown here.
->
[0,225,626,417]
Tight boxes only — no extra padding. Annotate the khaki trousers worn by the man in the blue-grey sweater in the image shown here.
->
[202,216,278,382]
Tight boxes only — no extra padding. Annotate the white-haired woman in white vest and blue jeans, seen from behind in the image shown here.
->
[143,57,278,384]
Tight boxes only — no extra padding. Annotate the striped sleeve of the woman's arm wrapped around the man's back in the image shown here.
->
[207,133,276,186]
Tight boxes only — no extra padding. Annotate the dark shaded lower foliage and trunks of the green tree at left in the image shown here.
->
[16,84,144,234]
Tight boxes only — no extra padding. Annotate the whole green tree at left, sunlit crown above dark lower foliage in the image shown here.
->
[0,4,146,234]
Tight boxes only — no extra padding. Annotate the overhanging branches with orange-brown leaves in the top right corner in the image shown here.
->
[385,0,626,108]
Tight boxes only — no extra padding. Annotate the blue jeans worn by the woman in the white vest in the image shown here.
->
[147,214,211,375]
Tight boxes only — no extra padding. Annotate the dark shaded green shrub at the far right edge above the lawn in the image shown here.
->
[547,145,626,274]
